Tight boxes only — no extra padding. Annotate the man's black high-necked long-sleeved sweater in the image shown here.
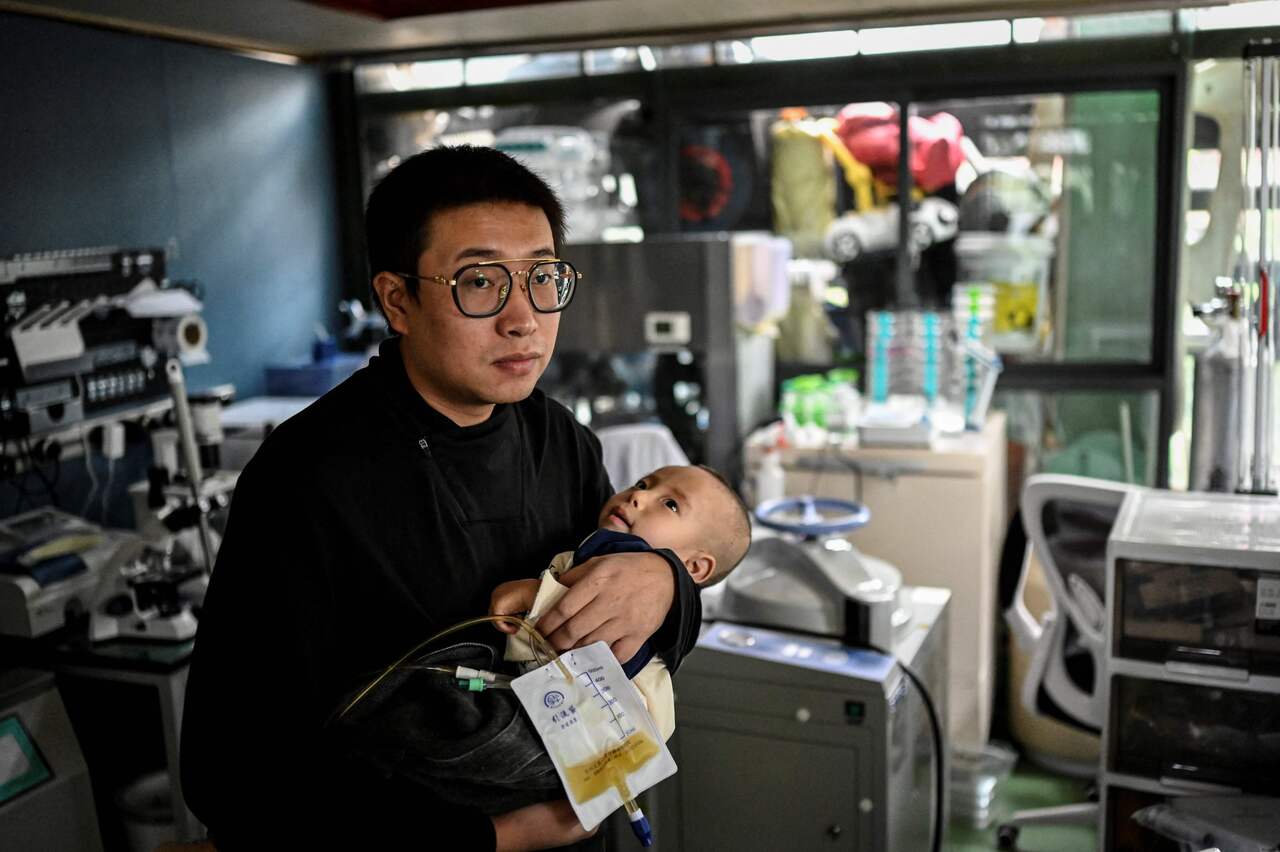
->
[182,339,700,849]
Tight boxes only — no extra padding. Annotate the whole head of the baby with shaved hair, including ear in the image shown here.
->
[599,466,751,586]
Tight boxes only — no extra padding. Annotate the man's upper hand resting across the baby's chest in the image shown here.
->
[538,553,676,663]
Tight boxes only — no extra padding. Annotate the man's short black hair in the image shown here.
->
[365,145,564,307]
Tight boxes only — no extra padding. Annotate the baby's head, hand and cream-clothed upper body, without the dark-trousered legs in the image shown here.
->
[489,466,751,739]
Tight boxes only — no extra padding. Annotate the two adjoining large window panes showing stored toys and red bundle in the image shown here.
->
[678,90,1161,376]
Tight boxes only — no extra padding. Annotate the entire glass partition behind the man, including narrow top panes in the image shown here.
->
[356,28,1177,487]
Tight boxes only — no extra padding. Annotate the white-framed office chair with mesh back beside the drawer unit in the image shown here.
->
[996,475,1138,849]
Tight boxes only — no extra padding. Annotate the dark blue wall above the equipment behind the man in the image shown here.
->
[0,13,340,398]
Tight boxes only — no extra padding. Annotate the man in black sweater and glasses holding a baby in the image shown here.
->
[182,147,699,851]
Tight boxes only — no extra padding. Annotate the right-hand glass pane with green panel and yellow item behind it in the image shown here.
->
[919,91,1160,362]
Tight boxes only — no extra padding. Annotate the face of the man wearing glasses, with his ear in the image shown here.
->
[375,202,559,425]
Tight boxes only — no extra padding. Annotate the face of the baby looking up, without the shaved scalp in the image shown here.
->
[599,467,724,553]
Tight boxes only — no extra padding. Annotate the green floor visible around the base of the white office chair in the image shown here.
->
[943,760,1097,852]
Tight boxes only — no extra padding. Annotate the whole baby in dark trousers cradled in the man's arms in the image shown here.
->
[335,467,751,814]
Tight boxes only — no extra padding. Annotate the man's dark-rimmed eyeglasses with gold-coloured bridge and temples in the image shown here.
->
[396,257,582,320]
